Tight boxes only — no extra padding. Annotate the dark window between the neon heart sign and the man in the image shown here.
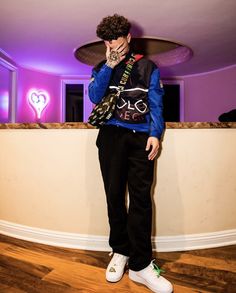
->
[66,84,84,122]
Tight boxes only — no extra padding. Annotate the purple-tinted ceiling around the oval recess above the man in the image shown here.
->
[0,0,236,76]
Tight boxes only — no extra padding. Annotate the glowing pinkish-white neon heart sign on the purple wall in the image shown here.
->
[28,89,50,119]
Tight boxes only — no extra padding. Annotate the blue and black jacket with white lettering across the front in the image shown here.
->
[89,55,165,139]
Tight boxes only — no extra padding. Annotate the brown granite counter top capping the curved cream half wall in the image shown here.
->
[0,122,236,129]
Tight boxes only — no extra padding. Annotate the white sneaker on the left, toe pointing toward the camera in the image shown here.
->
[106,253,129,282]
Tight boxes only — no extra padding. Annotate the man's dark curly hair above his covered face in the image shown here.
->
[96,14,131,41]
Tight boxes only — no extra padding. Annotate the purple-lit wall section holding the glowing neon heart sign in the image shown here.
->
[16,68,61,123]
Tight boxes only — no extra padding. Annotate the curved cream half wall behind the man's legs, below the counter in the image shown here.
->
[0,129,236,240]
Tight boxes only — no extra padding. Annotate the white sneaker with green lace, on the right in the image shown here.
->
[129,261,173,293]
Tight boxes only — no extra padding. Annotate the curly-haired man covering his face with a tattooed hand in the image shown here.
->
[89,14,173,293]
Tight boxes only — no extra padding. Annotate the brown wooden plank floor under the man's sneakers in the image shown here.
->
[0,235,236,293]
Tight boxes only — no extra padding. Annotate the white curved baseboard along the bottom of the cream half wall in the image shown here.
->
[0,220,236,252]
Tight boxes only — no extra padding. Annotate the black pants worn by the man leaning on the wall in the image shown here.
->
[96,126,154,271]
